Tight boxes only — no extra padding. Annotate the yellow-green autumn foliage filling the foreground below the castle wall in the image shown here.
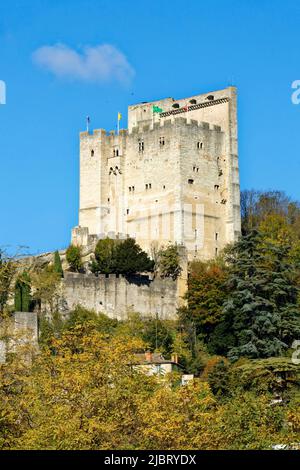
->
[0,308,300,449]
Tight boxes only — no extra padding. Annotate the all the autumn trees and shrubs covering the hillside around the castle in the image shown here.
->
[0,191,300,449]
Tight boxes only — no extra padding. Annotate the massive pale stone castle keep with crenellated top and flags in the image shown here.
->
[72,87,241,260]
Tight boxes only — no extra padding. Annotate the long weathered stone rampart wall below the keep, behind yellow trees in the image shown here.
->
[63,272,181,320]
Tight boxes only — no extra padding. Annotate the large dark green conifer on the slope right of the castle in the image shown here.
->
[224,230,300,360]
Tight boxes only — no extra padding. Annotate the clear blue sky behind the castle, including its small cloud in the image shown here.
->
[0,0,300,253]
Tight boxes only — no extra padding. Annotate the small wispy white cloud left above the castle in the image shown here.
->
[32,44,134,83]
